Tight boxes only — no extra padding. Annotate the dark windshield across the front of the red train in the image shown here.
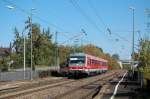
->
[69,56,85,66]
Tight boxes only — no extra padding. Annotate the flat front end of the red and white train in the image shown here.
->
[69,53,87,76]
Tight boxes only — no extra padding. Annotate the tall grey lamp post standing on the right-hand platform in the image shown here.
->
[129,6,135,74]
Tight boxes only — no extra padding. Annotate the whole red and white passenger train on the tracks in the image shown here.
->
[68,53,109,75]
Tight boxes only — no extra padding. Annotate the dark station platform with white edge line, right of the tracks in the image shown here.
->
[95,72,144,99]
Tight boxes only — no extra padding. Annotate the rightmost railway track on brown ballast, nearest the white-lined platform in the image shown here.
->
[52,70,123,99]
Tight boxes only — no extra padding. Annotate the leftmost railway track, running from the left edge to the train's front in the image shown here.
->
[0,78,72,99]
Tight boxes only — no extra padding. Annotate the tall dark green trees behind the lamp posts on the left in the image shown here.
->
[11,19,55,68]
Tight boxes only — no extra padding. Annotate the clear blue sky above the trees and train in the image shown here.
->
[0,0,150,59]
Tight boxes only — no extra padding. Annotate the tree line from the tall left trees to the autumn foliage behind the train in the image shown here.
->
[1,18,118,69]
